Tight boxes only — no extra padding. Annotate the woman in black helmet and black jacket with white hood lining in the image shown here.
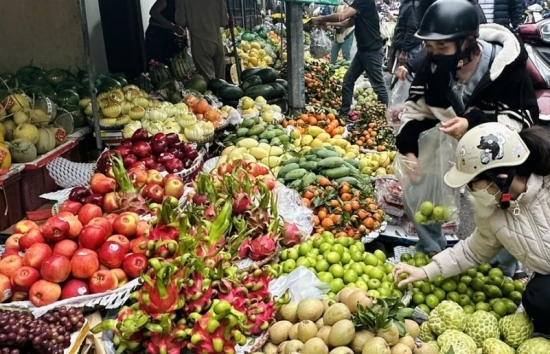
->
[396,0,539,254]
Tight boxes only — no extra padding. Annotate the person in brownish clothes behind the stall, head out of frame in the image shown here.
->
[176,0,229,82]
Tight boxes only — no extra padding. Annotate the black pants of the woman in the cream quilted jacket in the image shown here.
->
[522,274,550,335]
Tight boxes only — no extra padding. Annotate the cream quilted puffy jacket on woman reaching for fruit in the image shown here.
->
[423,175,550,280]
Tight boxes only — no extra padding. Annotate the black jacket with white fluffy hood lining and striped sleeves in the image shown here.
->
[396,24,539,155]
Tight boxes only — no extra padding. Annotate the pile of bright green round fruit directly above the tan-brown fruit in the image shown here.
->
[272,232,392,299]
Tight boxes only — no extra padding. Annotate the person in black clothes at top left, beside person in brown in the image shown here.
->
[145,0,185,64]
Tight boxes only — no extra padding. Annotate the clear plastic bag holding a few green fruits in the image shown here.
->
[393,125,460,225]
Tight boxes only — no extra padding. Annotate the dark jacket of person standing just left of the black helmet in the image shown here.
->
[393,0,422,53]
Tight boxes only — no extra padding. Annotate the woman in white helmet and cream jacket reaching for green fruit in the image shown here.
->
[394,123,550,334]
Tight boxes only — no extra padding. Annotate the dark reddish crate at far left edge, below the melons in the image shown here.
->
[0,173,23,232]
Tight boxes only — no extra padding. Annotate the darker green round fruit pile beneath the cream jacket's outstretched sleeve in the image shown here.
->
[401,252,525,318]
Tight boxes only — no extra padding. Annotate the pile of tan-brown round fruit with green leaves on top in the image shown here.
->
[256,294,423,354]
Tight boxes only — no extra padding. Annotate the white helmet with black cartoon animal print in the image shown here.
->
[444,123,530,188]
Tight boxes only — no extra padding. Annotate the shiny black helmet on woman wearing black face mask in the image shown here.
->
[415,0,479,41]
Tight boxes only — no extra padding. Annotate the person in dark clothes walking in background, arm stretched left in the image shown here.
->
[312,0,388,124]
